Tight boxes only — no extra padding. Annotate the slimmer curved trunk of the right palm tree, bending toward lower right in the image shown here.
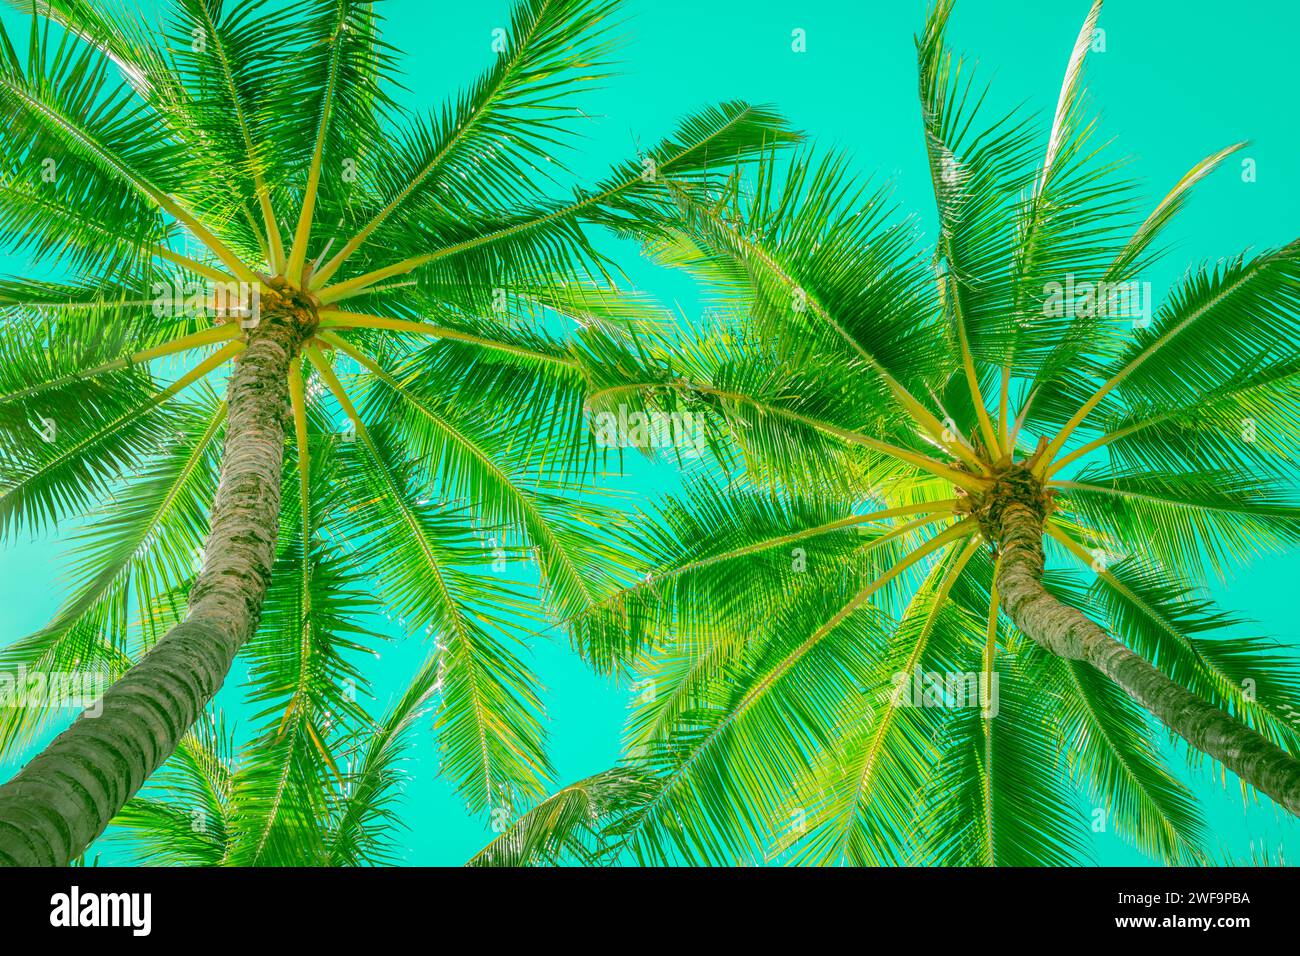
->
[997,502,1300,816]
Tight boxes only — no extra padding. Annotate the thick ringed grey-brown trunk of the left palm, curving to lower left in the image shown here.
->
[0,313,302,866]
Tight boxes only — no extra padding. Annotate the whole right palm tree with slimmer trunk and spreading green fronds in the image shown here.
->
[561,0,1300,865]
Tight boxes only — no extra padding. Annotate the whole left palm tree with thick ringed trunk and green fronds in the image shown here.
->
[0,0,789,865]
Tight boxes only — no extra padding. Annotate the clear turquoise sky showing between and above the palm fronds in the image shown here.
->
[0,0,1300,865]
